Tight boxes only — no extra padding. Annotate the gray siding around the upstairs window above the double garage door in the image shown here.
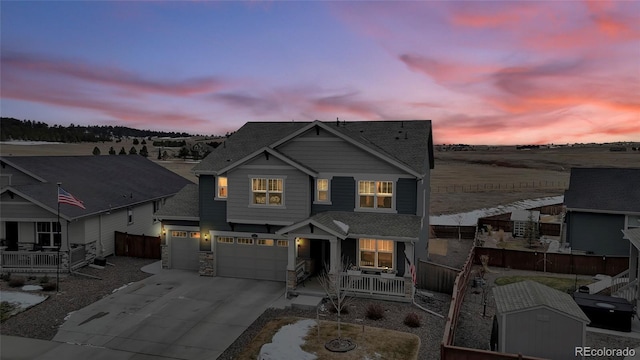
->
[227,155,311,224]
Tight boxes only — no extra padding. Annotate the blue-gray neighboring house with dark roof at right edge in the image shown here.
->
[564,168,640,256]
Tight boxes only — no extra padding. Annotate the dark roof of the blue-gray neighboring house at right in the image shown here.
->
[564,168,640,213]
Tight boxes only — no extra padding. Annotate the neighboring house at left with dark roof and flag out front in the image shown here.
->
[0,155,191,271]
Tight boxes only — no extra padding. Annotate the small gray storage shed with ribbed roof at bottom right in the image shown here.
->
[492,280,589,359]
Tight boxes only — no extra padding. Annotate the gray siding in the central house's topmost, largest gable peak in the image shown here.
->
[277,128,404,174]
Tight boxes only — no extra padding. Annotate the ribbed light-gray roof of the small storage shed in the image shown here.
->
[493,280,590,323]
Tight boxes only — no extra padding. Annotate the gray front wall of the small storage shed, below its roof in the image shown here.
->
[500,308,583,359]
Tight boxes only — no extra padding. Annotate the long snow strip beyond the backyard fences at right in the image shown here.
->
[429,195,564,226]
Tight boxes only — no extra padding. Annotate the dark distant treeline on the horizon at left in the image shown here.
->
[0,117,190,143]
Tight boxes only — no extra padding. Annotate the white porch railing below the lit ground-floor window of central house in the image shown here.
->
[340,273,406,297]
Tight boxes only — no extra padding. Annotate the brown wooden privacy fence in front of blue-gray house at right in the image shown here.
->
[474,247,629,276]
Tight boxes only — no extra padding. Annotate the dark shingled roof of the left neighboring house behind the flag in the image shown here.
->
[0,155,192,219]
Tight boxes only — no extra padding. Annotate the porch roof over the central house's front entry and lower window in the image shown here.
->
[277,211,422,241]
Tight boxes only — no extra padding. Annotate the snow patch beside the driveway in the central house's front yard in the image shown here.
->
[258,319,317,360]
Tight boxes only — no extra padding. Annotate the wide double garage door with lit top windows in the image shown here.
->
[216,238,287,281]
